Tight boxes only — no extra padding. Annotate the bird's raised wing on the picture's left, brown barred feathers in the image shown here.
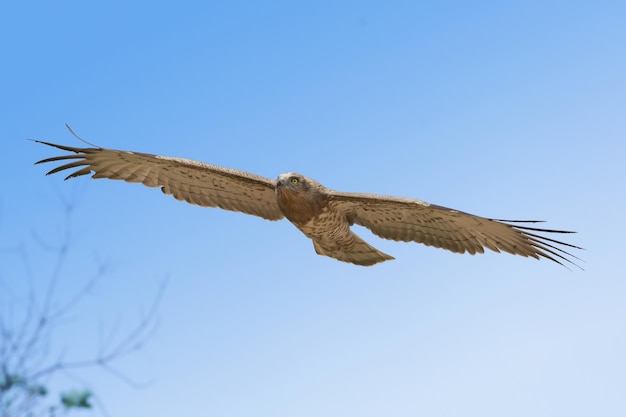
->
[36,141,283,220]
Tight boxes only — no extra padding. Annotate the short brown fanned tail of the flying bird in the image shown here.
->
[313,233,395,266]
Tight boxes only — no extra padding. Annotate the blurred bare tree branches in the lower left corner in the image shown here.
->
[0,196,167,417]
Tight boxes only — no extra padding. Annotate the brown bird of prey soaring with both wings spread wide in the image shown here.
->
[36,126,581,266]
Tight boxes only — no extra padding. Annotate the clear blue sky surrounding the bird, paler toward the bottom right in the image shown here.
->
[0,1,626,417]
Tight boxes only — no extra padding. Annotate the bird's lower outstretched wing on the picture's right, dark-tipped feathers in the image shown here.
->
[328,190,581,265]
